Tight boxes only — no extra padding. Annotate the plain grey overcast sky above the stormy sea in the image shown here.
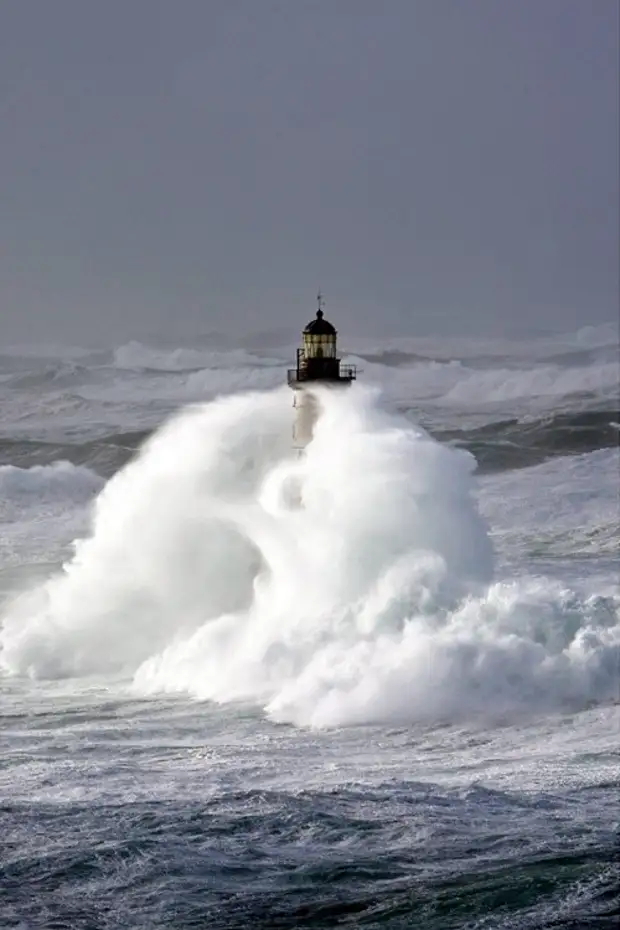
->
[0,0,620,345]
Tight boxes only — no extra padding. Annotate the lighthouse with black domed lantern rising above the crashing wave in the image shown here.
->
[288,292,356,451]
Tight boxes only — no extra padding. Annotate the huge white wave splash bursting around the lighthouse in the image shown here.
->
[0,386,620,726]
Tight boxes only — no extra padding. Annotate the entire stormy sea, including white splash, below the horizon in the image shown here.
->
[0,327,620,930]
